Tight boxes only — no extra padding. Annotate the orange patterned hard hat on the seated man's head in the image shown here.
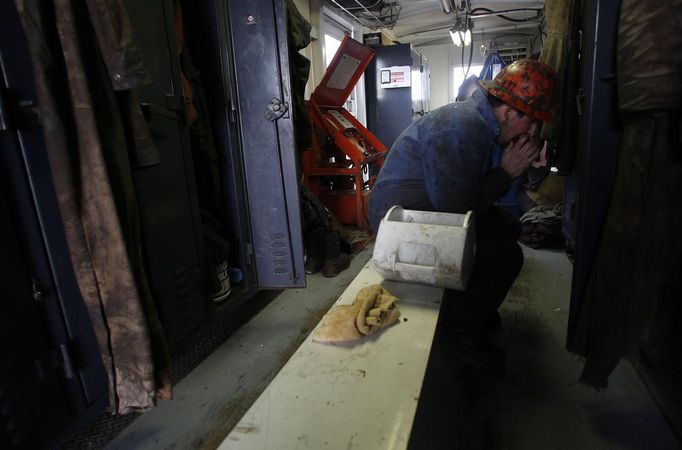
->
[481,59,556,122]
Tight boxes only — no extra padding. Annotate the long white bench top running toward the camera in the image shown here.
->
[219,261,443,450]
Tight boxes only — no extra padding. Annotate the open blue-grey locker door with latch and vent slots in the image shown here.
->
[227,0,305,288]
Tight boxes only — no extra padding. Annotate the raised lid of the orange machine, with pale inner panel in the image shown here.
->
[311,36,374,107]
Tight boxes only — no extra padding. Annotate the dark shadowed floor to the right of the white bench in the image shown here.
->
[410,247,680,450]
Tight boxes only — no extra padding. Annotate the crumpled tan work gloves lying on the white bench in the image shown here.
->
[313,284,400,344]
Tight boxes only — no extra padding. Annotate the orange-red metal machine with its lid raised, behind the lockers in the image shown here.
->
[303,36,388,230]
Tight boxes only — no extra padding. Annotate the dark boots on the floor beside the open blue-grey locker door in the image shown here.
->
[305,230,350,278]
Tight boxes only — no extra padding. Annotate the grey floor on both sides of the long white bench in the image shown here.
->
[107,246,681,450]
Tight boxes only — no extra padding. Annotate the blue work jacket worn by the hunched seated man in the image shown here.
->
[369,87,511,232]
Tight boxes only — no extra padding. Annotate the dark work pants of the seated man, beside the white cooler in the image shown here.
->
[441,207,523,336]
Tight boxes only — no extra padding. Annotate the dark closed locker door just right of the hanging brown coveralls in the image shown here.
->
[124,0,207,351]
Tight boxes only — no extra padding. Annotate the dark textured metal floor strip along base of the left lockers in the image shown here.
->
[61,291,280,450]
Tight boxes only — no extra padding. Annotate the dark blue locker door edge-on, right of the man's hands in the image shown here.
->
[562,1,620,345]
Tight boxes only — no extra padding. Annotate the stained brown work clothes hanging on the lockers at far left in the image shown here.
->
[16,0,170,413]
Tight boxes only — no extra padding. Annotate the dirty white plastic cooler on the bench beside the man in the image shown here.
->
[372,206,476,290]
